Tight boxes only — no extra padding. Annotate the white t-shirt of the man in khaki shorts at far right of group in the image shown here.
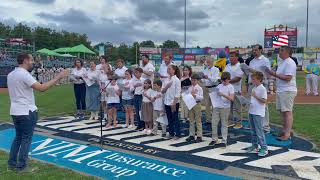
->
[276,57,297,92]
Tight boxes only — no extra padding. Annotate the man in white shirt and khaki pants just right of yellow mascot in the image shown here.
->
[224,51,243,129]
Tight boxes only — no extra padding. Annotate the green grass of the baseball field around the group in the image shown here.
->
[0,73,320,180]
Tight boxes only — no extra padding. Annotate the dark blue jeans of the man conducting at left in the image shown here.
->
[8,111,38,170]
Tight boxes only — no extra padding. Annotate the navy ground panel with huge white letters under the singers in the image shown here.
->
[37,116,320,179]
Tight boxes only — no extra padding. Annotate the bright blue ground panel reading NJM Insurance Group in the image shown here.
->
[0,128,235,180]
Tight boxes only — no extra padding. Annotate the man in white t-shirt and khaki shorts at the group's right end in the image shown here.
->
[267,46,297,141]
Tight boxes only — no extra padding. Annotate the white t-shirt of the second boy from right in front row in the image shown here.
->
[212,84,234,108]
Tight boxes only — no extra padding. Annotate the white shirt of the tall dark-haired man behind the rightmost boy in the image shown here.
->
[248,55,271,83]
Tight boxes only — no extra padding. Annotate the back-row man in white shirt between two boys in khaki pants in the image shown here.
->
[201,56,220,123]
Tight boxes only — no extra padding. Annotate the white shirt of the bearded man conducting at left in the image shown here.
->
[7,67,37,116]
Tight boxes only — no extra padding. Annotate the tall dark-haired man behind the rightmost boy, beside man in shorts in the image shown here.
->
[247,44,270,133]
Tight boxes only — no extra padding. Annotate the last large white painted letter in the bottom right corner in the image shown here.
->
[246,149,320,180]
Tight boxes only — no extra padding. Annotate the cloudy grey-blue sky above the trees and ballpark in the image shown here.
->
[0,0,320,47]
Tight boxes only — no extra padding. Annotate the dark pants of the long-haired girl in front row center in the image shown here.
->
[165,103,181,137]
